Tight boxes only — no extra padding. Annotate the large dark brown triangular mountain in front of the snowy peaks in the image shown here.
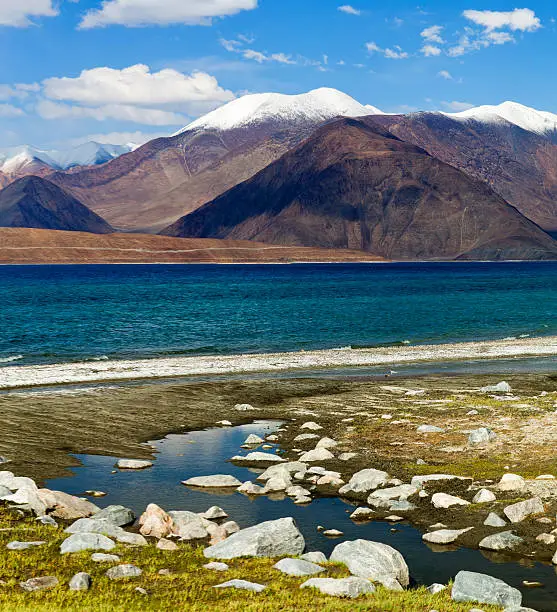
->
[164,119,557,259]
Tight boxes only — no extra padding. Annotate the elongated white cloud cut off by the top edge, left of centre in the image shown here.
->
[79,0,257,29]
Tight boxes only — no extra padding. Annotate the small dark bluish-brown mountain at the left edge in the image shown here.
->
[0,176,112,234]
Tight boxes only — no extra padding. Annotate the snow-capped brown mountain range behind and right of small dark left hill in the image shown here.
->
[0,89,557,259]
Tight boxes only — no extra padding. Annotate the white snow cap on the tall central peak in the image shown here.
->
[178,88,383,134]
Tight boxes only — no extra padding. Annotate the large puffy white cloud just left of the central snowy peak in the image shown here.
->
[43,64,234,108]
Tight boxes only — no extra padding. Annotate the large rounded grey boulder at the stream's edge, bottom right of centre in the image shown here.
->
[330,540,410,591]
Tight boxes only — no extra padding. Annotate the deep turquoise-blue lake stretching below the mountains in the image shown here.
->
[0,262,557,367]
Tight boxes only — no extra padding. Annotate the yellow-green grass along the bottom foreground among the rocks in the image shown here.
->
[0,511,499,612]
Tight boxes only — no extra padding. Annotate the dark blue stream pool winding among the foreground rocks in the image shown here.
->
[47,421,557,611]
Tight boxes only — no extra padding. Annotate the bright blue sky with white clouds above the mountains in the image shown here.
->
[0,0,557,149]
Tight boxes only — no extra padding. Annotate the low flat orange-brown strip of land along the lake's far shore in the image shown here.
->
[0,228,382,264]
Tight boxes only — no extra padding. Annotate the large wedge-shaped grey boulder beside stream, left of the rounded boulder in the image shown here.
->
[203,517,305,559]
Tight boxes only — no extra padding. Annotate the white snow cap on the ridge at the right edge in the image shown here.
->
[444,102,557,136]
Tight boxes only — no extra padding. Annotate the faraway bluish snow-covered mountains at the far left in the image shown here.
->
[0,142,134,175]
